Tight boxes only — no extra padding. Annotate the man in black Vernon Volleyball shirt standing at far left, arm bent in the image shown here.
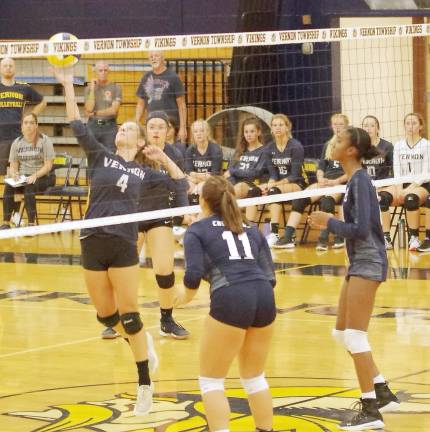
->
[0,57,46,176]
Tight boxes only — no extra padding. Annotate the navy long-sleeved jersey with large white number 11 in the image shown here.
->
[184,216,275,293]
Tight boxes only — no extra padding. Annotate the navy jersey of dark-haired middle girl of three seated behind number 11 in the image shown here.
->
[228,146,268,183]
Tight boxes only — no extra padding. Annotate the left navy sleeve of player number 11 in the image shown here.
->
[184,230,205,289]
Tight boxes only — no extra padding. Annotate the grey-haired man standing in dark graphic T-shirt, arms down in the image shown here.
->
[136,51,187,143]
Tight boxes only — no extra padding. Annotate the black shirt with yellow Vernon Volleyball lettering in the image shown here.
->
[0,82,43,142]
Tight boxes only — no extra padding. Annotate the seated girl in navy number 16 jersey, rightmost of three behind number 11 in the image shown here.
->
[265,114,306,247]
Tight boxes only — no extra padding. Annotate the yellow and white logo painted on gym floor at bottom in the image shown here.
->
[6,386,430,432]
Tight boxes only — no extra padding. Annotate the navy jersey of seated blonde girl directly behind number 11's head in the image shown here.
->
[185,142,222,174]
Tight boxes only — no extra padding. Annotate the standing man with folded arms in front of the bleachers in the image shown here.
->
[85,60,122,153]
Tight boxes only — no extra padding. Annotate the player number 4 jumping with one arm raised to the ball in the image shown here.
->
[54,69,184,415]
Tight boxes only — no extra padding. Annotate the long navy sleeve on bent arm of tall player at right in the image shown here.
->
[327,176,373,240]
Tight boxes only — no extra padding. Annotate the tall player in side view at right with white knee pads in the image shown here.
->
[309,127,399,431]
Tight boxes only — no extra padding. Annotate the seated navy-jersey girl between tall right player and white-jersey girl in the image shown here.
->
[361,115,396,249]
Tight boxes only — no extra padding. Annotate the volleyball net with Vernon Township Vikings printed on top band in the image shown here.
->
[0,24,430,238]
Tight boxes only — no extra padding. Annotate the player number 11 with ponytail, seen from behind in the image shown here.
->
[177,176,276,432]
